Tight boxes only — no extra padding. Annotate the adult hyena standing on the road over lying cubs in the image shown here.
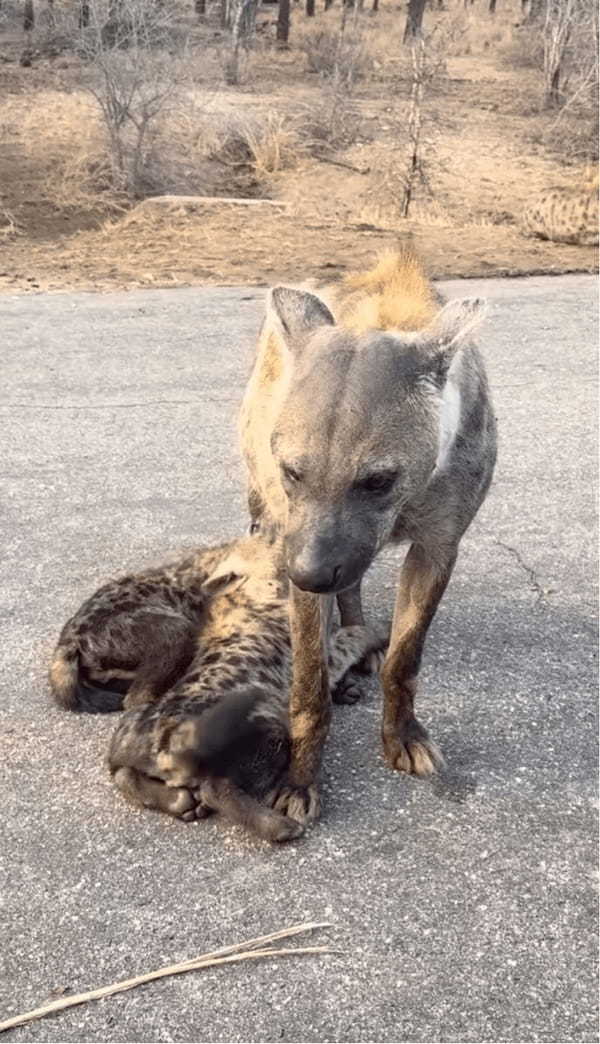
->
[241,250,496,820]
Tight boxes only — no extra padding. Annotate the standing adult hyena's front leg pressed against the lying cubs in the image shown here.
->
[274,584,333,823]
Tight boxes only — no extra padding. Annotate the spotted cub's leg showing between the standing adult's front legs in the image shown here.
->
[329,624,389,704]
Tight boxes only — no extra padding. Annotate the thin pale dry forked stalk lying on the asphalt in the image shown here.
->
[0,921,336,1033]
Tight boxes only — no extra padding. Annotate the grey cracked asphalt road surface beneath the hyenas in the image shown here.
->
[0,277,598,1042]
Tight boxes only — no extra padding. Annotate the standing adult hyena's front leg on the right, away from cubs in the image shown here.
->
[382,544,456,776]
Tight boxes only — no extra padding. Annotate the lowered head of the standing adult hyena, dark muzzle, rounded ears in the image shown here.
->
[267,287,483,592]
